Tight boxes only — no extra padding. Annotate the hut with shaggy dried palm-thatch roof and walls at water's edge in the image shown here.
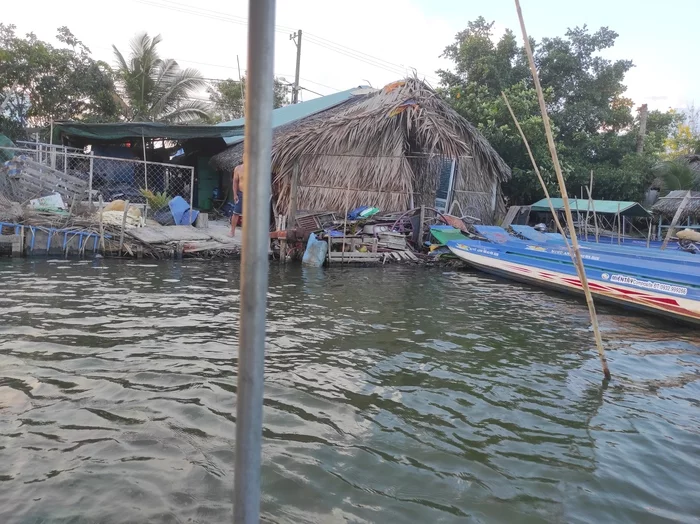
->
[212,78,510,223]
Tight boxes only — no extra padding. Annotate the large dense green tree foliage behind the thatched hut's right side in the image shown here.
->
[438,17,675,204]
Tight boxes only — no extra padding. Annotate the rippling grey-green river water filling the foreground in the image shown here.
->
[0,260,700,524]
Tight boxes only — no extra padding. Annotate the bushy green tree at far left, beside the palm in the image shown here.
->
[0,23,118,138]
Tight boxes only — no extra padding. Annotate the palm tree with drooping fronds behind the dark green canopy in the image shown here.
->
[112,33,209,123]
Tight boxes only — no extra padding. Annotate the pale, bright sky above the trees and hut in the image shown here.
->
[2,0,700,110]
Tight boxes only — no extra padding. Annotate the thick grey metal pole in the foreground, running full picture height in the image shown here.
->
[233,0,275,524]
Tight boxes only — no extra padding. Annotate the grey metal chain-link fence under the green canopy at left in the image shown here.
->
[0,142,194,211]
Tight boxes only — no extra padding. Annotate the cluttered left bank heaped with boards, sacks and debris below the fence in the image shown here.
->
[0,155,240,259]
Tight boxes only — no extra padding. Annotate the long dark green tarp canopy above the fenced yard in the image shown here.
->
[54,122,244,144]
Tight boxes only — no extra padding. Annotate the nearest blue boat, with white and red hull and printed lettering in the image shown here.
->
[447,231,700,324]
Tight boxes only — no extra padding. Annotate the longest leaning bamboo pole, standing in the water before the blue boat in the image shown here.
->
[515,0,610,380]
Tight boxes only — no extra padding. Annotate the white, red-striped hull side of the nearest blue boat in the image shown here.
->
[448,242,700,325]
